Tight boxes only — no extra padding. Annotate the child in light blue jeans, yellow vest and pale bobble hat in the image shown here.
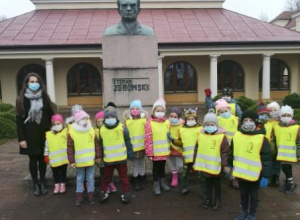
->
[68,110,101,206]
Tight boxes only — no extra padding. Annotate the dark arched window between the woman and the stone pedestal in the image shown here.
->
[67,63,102,96]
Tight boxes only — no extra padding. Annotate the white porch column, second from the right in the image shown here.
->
[209,55,220,98]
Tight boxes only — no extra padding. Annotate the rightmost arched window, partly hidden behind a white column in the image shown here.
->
[259,59,290,90]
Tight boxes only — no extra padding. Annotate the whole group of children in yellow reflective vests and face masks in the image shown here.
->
[45,88,300,220]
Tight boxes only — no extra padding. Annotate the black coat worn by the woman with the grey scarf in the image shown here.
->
[17,97,54,156]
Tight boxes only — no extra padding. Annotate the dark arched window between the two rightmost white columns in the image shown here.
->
[218,60,244,91]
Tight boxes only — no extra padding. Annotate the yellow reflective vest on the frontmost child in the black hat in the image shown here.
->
[232,131,265,182]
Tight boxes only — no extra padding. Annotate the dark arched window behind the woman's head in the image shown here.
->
[17,64,47,93]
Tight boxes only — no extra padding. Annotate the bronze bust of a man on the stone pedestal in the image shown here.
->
[104,0,155,36]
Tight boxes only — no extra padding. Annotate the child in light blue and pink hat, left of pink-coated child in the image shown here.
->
[125,100,146,191]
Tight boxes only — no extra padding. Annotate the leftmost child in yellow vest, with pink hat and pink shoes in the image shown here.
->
[44,114,69,194]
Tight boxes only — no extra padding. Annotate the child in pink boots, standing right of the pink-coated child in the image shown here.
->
[169,107,183,187]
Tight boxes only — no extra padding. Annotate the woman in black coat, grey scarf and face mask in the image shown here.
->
[16,73,54,196]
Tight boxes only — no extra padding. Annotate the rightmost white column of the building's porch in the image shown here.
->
[262,54,271,99]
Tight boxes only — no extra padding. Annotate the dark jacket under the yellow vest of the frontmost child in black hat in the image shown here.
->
[229,127,272,178]
